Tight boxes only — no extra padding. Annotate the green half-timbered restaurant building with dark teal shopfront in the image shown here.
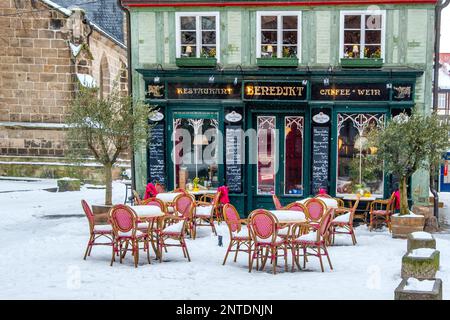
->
[122,0,436,212]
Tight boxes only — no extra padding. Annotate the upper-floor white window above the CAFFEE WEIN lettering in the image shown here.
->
[340,10,386,59]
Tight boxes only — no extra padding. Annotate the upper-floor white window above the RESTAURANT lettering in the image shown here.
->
[176,12,220,58]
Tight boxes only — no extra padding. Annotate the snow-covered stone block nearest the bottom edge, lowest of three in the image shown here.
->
[394,278,442,300]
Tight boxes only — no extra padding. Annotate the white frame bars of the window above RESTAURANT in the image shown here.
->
[175,11,220,62]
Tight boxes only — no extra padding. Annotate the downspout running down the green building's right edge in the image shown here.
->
[430,0,450,226]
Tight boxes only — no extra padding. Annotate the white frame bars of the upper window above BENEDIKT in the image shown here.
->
[256,11,302,61]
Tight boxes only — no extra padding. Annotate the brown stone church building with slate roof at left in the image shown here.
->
[0,0,129,178]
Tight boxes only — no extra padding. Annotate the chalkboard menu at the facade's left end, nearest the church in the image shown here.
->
[148,123,166,185]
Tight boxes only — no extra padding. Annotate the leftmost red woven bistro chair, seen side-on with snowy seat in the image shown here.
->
[81,200,114,260]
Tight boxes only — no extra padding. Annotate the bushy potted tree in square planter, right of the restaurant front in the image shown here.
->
[372,109,450,237]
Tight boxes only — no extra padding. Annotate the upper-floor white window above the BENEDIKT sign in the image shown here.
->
[256,11,301,58]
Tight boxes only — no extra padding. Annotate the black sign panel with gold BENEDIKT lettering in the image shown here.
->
[244,81,307,101]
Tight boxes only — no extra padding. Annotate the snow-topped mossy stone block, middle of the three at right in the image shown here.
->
[401,248,440,279]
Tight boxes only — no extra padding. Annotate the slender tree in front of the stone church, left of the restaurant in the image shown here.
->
[65,84,152,220]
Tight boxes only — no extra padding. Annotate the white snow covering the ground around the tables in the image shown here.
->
[0,180,450,299]
